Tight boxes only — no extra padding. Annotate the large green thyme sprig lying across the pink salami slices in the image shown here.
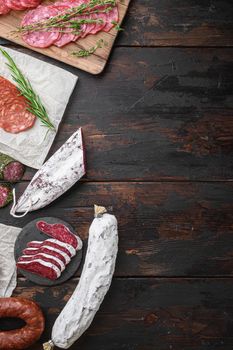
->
[16,0,116,33]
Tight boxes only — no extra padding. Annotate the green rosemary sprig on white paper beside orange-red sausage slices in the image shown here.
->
[0,48,55,130]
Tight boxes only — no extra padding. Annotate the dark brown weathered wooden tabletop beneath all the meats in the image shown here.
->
[1,0,233,350]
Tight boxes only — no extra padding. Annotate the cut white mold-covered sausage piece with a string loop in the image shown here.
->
[11,128,85,217]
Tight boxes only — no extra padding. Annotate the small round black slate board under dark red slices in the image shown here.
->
[15,217,82,286]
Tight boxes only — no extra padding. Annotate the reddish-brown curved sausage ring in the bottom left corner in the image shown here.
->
[0,298,45,350]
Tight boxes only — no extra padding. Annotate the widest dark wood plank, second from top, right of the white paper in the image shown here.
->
[12,48,233,181]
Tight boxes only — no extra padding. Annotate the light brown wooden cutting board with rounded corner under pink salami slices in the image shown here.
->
[0,0,130,74]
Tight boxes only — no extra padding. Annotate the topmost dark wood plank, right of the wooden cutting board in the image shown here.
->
[117,0,233,46]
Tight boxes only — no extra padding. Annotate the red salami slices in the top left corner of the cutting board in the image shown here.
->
[0,0,41,15]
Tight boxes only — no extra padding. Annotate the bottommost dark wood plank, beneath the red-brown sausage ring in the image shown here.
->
[10,278,233,350]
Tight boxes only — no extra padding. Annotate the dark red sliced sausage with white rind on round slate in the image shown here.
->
[17,221,82,280]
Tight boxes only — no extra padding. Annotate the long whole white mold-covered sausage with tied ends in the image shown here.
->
[44,206,118,350]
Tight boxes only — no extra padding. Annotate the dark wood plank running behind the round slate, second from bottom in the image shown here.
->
[0,183,233,276]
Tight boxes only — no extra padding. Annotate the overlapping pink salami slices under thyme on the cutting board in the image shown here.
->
[21,0,119,48]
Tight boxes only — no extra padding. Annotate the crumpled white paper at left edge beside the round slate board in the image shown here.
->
[0,224,22,298]
